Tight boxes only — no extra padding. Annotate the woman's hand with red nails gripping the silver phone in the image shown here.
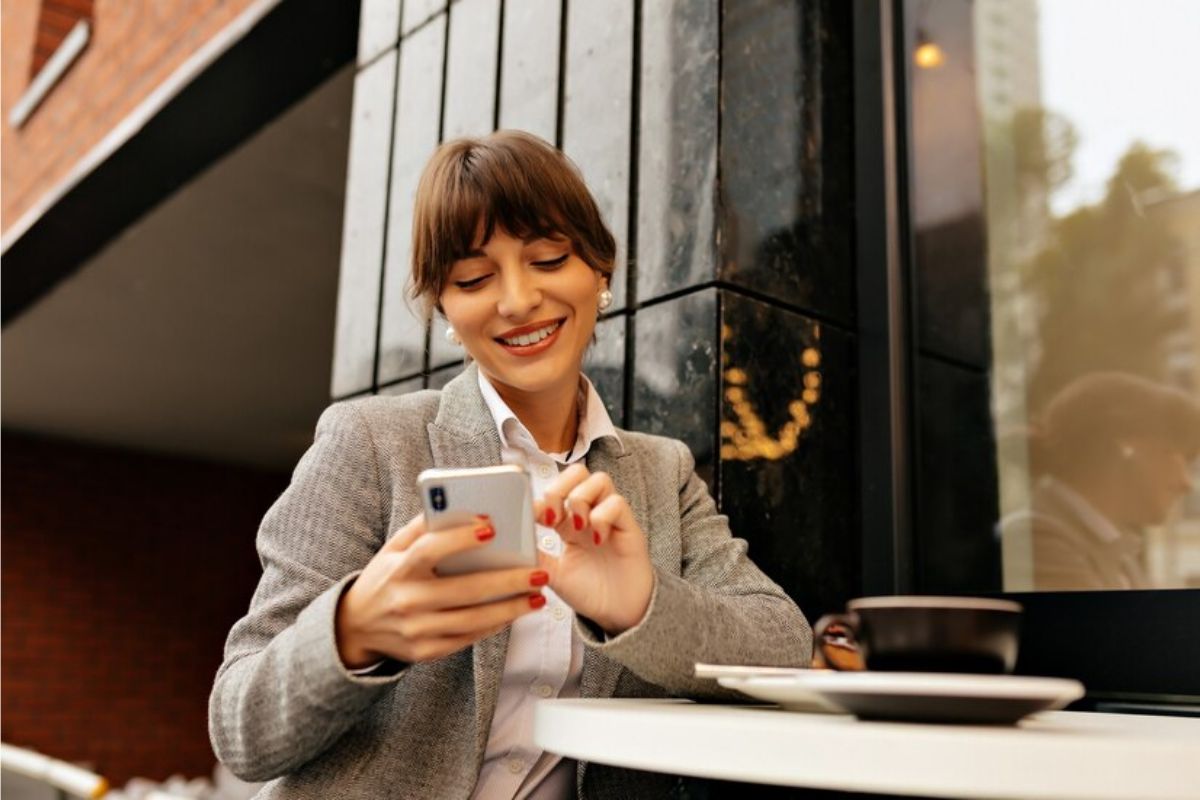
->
[336,515,548,669]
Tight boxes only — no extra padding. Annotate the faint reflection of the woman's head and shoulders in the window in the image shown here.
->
[1001,372,1200,591]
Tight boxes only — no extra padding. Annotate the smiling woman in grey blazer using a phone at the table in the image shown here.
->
[210,132,811,799]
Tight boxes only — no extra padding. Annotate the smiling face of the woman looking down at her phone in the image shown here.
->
[439,228,605,393]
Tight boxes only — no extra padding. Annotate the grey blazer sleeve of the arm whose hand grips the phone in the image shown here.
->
[209,403,403,781]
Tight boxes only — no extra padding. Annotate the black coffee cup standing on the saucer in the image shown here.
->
[814,596,1021,674]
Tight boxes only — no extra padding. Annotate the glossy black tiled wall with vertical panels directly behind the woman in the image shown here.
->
[331,0,860,615]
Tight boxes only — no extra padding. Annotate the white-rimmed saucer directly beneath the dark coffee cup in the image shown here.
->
[720,670,1084,724]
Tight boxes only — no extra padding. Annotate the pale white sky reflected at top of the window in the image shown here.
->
[1040,0,1200,212]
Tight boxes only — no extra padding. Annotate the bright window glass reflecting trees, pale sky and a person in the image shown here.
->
[974,0,1200,590]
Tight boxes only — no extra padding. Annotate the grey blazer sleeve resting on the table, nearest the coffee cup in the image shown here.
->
[577,441,812,698]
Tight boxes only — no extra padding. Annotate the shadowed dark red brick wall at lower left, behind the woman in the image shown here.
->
[0,433,288,786]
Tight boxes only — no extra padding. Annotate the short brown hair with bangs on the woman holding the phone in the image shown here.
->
[410,131,617,309]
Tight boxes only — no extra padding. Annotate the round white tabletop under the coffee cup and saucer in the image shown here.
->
[534,699,1200,800]
